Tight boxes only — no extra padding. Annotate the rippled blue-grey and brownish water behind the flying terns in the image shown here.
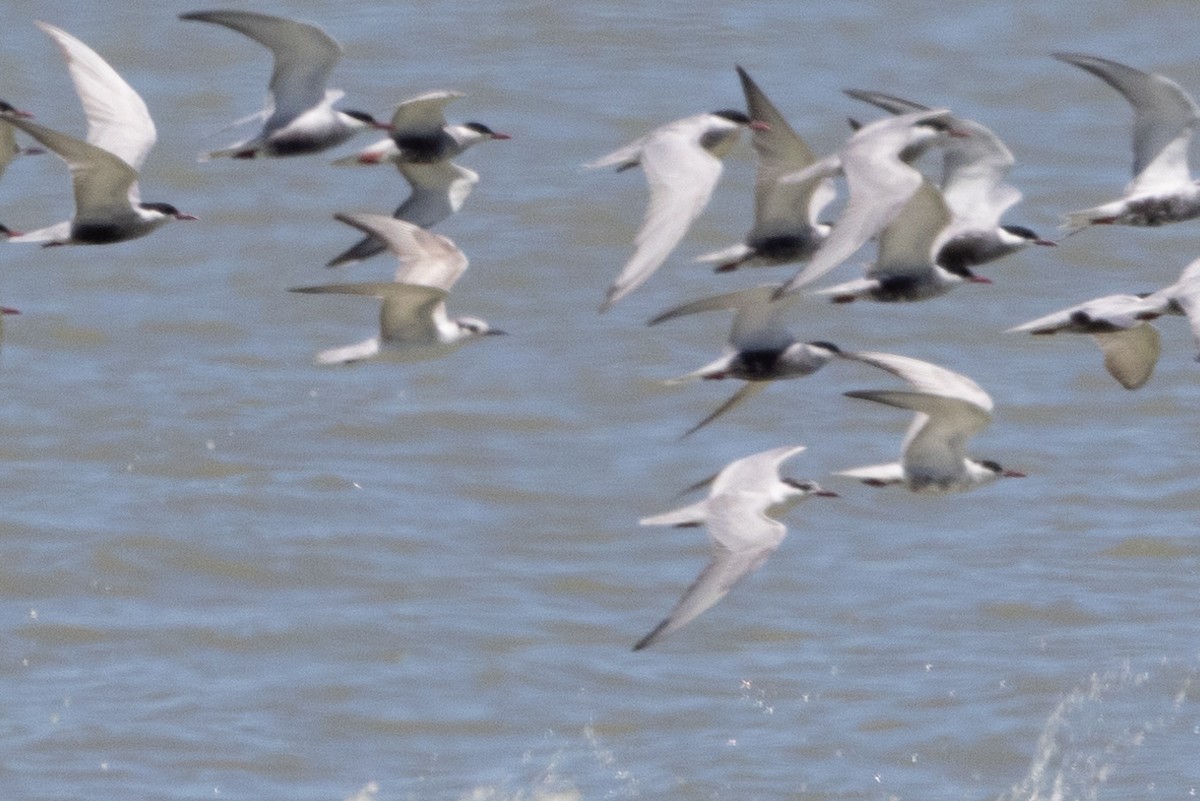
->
[0,0,1200,801]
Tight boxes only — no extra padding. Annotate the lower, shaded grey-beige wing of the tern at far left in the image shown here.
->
[4,115,138,215]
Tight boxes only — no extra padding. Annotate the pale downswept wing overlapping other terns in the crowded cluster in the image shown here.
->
[778,110,949,294]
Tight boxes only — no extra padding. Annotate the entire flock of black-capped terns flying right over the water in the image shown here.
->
[0,11,1200,650]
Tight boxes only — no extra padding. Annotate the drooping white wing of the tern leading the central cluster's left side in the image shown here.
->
[600,115,721,311]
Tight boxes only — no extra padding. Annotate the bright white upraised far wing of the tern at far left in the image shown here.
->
[37,22,157,173]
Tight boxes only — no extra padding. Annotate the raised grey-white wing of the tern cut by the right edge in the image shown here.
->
[1052,53,1200,194]
